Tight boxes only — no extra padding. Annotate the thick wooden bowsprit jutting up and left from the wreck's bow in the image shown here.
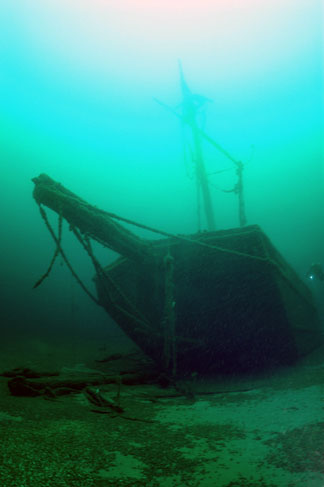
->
[32,174,153,262]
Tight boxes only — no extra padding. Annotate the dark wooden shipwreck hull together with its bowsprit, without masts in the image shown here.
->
[33,175,321,375]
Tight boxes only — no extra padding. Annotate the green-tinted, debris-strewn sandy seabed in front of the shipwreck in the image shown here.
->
[0,339,324,487]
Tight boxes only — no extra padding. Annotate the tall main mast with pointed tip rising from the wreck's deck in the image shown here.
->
[179,62,216,230]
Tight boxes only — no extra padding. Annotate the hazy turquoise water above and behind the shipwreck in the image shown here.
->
[0,0,324,334]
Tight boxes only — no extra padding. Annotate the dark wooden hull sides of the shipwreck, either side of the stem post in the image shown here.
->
[95,226,321,375]
